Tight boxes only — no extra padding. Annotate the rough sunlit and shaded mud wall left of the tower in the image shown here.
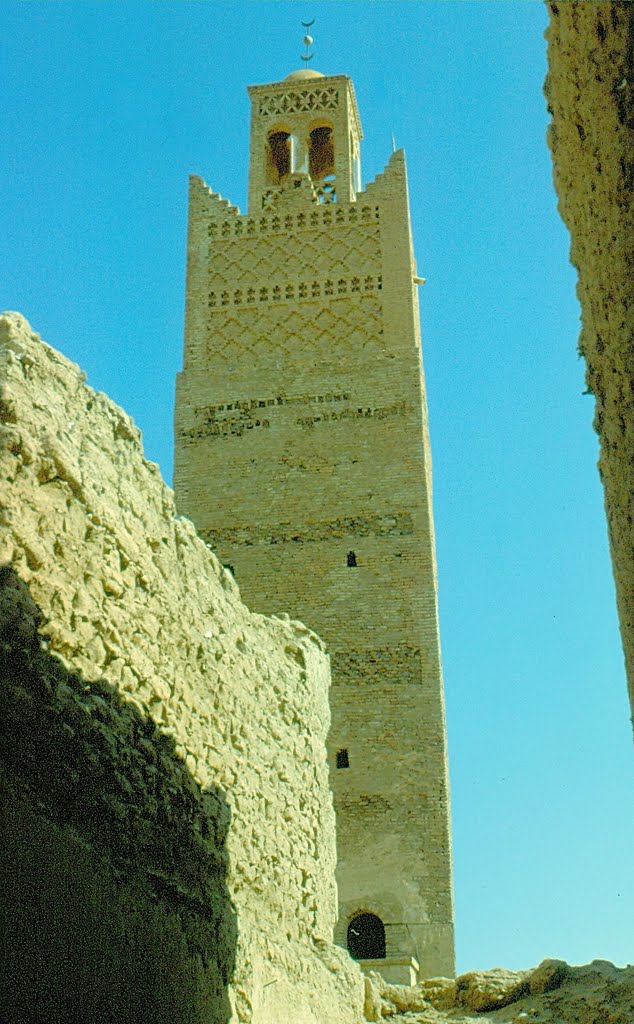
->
[0,314,363,1024]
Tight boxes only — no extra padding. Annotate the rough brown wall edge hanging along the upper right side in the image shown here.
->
[546,0,634,733]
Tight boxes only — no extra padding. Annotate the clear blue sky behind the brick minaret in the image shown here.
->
[0,0,634,971]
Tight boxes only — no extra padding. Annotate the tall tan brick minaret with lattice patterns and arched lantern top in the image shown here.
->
[175,70,454,981]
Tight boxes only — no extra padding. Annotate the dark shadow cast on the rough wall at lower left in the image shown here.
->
[0,566,238,1024]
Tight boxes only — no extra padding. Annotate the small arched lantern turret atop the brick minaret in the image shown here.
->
[249,68,363,213]
